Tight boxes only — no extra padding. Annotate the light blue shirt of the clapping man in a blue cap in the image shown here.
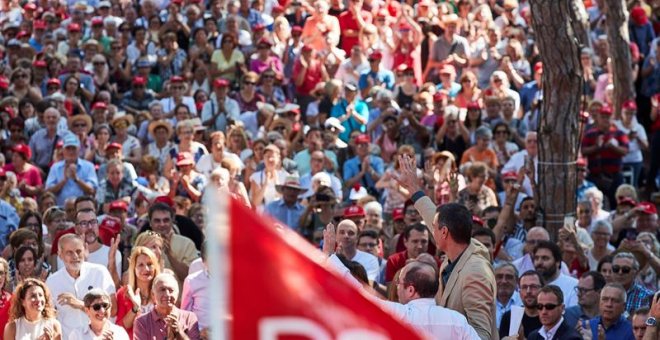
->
[46,158,98,207]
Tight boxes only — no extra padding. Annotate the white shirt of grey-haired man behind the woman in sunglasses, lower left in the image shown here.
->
[46,262,115,339]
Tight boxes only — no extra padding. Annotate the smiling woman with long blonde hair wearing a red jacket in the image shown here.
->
[116,246,162,339]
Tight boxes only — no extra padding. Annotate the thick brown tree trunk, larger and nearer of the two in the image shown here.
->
[529,0,587,240]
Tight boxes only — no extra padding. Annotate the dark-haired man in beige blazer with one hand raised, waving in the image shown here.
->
[397,155,498,340]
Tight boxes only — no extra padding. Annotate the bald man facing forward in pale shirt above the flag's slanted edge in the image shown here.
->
[337,220,379,281]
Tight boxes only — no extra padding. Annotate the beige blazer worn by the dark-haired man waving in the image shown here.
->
[415,196,499,340]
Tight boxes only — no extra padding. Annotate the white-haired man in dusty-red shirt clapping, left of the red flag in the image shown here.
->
[133,273,200,340]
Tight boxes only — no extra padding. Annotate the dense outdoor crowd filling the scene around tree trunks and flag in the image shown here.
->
[0,0,660,340]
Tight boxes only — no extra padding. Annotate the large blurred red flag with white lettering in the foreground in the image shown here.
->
[227,200,422,340]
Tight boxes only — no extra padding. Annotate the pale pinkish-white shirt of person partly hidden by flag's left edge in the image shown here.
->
[181,270,211,329]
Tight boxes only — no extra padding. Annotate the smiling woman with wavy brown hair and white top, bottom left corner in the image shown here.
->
[4,279,62,340]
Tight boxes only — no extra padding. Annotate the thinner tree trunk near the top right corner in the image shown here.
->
[603,0,635,118]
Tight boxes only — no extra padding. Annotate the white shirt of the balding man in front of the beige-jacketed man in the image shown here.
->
[377,298,479,340]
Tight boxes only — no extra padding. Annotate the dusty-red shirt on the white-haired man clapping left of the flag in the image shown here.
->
[133,307,200,340]
